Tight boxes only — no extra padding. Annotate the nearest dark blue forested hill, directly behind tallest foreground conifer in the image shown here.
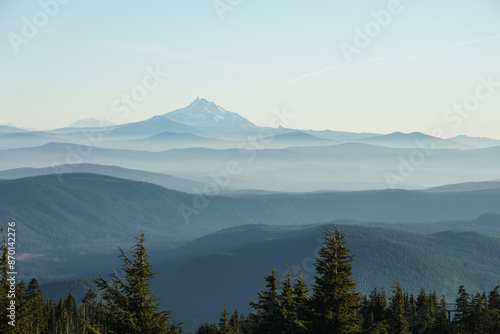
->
[154,221,500,329]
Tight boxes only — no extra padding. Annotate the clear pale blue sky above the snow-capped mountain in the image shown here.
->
[0,0,500,139]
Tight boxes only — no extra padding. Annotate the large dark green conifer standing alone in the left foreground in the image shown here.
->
[96,233,182,334]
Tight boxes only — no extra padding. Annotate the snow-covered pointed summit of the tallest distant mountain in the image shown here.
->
[163,97,255,129]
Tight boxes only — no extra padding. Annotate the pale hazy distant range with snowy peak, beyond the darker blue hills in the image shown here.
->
[0,98,500,192]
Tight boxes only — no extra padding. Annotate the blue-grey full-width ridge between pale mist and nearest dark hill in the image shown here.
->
[0,173,500,253]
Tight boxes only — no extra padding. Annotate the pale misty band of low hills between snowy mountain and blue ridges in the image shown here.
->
[0,141,500,192]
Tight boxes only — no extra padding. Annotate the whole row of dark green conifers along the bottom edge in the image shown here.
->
[0,228,500,334]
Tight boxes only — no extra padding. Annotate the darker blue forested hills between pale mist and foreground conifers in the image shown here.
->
[0,172,500,329]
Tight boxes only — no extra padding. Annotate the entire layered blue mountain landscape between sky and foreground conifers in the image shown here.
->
[0,94,500,330]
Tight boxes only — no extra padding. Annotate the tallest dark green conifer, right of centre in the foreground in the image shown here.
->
[311,227,361,334]
